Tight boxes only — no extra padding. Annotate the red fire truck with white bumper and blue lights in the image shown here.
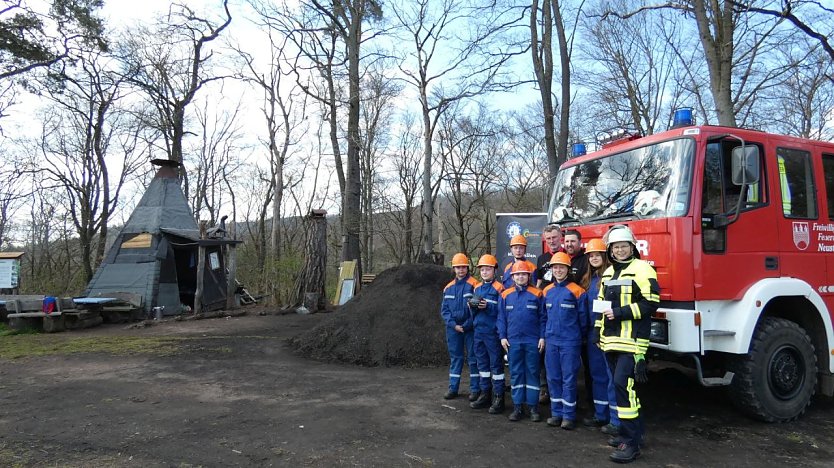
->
[548,114,834,421]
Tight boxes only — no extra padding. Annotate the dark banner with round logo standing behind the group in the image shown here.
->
[495,213,547,272]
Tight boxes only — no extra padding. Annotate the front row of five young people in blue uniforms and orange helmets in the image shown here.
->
[441,239,618,434]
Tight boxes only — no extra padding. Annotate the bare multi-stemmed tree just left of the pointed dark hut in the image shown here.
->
[33,54,142,281]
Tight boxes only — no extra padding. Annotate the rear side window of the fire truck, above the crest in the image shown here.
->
[776,148,817,218]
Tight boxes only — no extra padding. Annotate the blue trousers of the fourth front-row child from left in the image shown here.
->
[544,343,582,421]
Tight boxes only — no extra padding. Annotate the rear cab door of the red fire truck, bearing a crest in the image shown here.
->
[776,148,834,292]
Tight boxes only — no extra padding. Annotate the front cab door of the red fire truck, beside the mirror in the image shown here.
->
[694,138,779,300]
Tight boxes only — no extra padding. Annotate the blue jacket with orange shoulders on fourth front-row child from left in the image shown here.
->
[544,280,588,346]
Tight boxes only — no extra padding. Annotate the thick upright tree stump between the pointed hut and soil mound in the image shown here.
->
[296,210,327,312]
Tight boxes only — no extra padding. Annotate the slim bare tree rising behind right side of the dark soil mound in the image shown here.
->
[393,0,526,257]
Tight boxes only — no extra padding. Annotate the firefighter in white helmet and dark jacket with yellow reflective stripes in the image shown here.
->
[595,225,660,463]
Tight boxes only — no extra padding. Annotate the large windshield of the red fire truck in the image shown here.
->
[549,138,695,224]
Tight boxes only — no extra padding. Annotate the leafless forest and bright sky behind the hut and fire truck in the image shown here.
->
[0,0,834,304]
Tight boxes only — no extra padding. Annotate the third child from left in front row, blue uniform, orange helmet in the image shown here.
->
[496,262,546,422]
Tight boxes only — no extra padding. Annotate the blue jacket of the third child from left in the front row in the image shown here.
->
[496,286,547,345]
